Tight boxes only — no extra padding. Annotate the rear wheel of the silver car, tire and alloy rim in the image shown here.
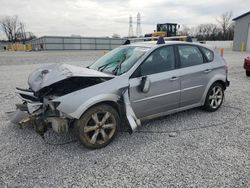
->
[203,82,224,112]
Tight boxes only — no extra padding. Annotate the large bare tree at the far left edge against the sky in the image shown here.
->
[0,16,26,42]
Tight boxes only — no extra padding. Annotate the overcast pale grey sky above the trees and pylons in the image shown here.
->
[0,0,250,36]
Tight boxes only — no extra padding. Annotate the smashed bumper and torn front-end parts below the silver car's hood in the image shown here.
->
[11,88,72,136]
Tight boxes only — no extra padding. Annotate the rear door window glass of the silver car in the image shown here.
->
[178,45,204,68]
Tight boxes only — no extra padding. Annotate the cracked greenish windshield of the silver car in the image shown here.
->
[89,46,149,75]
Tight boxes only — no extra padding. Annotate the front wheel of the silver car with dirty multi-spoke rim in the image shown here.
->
[75,104,120,149]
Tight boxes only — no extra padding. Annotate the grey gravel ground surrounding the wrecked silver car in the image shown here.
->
[0,51,250,187]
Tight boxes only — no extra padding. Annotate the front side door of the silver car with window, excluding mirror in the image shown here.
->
[129,46,180,118]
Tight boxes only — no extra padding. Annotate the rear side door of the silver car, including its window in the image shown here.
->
[177,45,212,107]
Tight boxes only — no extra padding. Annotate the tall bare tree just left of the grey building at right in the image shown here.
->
[217,11,233,40]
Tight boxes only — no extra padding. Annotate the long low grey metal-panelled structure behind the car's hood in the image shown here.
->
[26,36,126,50]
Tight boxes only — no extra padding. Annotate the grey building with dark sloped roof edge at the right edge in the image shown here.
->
[233,11,250,51]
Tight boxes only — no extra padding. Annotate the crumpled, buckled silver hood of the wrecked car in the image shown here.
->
[28,64,114,92]
